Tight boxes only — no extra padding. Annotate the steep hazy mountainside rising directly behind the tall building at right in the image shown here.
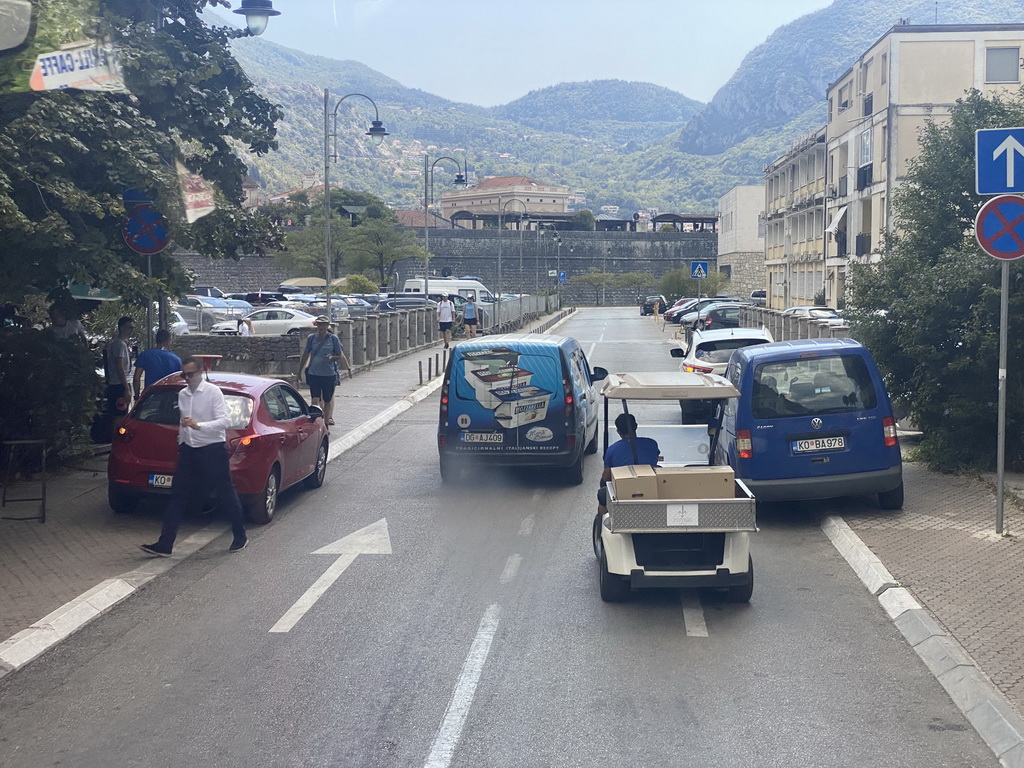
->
[674,0,1021,155]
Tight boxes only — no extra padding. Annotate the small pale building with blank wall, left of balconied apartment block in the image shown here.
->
[716,184,765,296]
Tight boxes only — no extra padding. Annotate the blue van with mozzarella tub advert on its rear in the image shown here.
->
[437,333,608,484]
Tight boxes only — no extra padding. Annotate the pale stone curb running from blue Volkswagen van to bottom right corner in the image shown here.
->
[821,515,1024,768]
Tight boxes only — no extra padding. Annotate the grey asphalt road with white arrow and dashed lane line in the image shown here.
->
[0,309,997,768]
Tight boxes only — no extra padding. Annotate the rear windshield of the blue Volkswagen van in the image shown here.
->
[751,354,879,419]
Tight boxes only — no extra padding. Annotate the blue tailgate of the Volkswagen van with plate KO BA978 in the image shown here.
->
[736,352,899,480]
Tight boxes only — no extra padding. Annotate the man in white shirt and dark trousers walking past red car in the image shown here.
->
[141,357,249,557]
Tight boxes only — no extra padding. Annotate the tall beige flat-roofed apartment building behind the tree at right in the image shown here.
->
[825,25,1024,305]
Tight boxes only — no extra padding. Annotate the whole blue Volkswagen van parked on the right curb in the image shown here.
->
[717,339,903,509]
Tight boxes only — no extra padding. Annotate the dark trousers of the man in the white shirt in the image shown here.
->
[158,442,246,549]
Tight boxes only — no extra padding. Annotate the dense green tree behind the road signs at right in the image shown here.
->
[850,91,1024,469]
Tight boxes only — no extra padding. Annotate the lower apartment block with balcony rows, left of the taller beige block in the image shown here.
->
[762,128,838,309]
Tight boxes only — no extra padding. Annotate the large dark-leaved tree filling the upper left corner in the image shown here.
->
[0,0,281,309]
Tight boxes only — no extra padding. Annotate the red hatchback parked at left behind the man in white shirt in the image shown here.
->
[106,372,329,523]
